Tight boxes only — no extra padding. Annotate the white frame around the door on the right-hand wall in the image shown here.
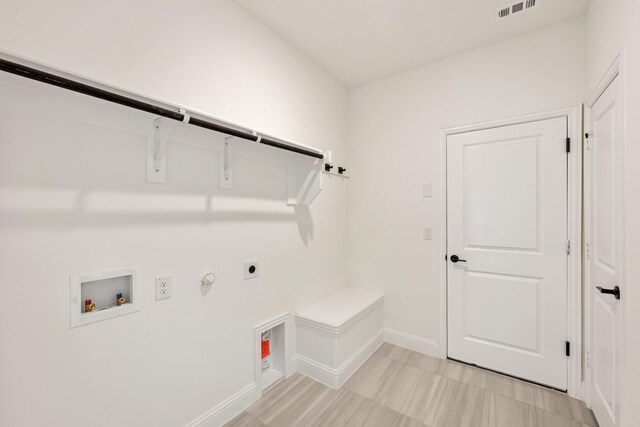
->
[584,51,627,422]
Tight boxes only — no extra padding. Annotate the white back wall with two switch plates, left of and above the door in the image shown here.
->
[349,18,585,350]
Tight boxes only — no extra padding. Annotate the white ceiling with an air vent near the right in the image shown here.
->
[234,0,588,87]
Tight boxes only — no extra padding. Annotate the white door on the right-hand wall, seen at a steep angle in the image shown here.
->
[585,79,624,427]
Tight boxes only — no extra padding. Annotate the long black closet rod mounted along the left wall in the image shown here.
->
[0,58,324,159]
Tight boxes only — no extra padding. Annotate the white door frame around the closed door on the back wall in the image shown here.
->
[439,105,584,399]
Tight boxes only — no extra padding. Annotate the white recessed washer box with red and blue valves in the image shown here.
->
[69,268,140,328]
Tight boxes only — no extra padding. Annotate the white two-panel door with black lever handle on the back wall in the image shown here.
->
[447,118,568,390]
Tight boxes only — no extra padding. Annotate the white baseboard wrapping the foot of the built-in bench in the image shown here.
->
[295,329,384,389]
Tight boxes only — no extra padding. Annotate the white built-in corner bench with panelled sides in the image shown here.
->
[295,288,384,388]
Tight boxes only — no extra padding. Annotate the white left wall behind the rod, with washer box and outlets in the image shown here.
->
[0,0,347,426]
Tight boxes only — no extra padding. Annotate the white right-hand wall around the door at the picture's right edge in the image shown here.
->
[587,0,640,426]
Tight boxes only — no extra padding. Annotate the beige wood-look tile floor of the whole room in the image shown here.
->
[226,343,598,427]
